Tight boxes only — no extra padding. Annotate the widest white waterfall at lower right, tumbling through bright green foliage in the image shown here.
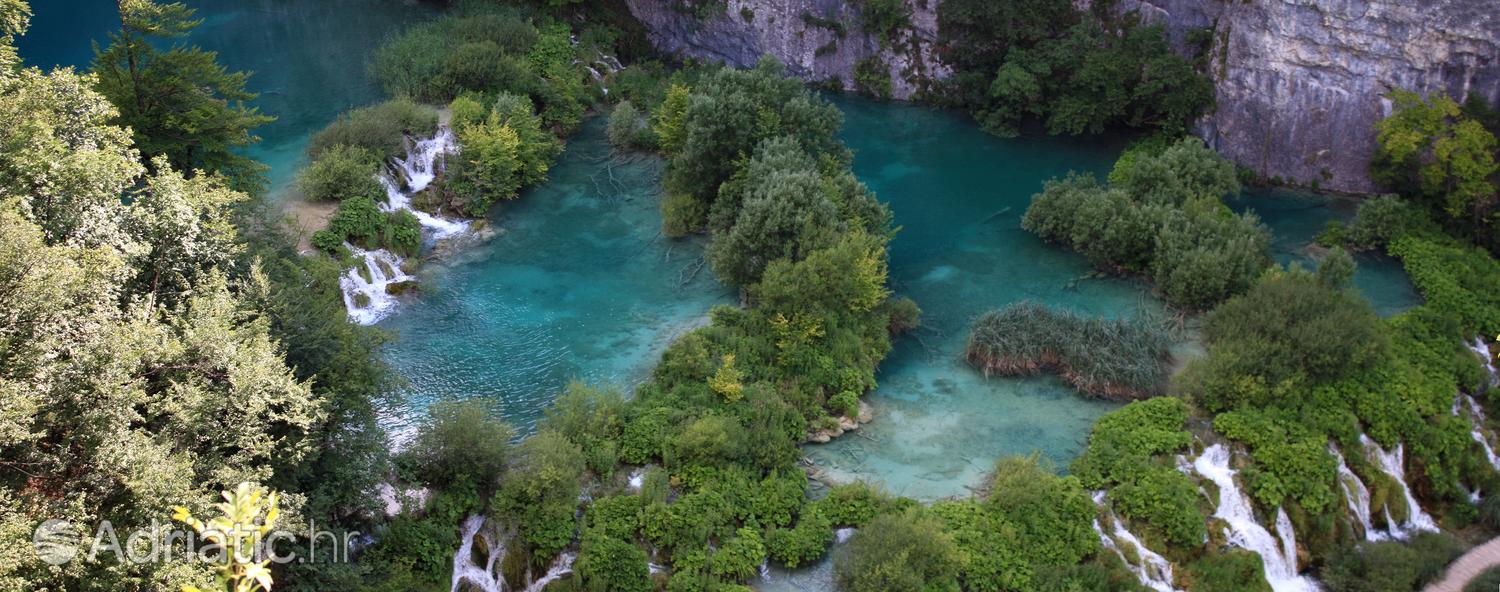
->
[1193,444,1319,592]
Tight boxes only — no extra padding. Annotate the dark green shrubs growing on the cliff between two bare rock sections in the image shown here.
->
[938,0,1214,136]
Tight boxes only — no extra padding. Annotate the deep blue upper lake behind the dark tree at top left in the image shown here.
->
[18,0,435,194]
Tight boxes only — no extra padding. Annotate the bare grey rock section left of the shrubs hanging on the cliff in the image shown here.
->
[627,0,950,99]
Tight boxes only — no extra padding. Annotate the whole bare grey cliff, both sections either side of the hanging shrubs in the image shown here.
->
[627,0,1500,193]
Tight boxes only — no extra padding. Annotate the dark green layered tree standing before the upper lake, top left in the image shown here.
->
[93,0,276,189]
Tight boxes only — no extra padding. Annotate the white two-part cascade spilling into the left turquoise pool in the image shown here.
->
[339,126,470,325]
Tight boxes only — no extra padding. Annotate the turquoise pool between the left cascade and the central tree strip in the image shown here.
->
[372,117,735,432]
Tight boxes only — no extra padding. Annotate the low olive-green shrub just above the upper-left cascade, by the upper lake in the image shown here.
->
[308,99,438,162]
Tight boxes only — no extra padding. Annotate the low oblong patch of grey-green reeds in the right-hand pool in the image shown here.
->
[965,303,1172,399]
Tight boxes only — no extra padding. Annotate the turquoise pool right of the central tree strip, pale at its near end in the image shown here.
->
[806,97,1419,499]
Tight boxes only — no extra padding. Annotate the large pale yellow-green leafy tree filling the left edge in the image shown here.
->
[0,0,405,589]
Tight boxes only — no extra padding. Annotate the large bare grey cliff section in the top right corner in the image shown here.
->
[1121,0,1500,193]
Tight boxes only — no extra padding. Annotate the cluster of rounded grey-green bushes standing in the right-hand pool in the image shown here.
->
[1022,138,1271,310]
